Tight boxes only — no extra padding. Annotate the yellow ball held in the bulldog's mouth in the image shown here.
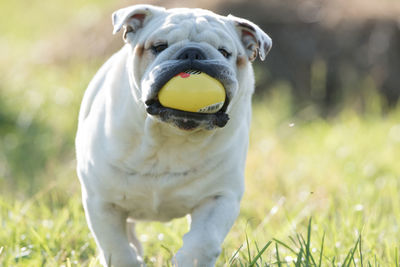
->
[158,70,225,113]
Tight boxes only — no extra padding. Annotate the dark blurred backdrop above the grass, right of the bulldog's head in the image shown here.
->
[217,0,400,114]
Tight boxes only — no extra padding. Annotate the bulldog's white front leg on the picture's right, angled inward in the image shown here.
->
[173,195,240,267]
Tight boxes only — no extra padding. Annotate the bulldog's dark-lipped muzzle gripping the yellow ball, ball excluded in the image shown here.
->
[144,60,237,130]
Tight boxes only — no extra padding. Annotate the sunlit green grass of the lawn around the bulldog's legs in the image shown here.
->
[0,97,400,266]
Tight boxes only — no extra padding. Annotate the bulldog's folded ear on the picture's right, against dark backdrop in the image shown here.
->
[228,15,272,61]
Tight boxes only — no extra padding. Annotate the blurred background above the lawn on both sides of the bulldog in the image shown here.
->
[0,0,400,197]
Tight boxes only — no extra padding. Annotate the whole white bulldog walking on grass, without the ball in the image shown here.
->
[76,5,272,267]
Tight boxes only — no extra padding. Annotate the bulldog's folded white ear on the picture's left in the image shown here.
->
[112,5,165,41]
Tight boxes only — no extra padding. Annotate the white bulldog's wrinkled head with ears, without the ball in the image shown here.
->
[113,5,272,130]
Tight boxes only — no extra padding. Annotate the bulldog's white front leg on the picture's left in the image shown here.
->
[84,199,144,267]
